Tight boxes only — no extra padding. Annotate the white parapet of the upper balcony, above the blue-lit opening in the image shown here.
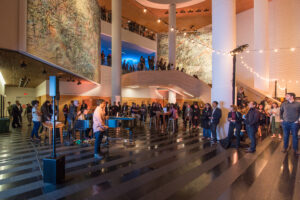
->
[101,21,157,52]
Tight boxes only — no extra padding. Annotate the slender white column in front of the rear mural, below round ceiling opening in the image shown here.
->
[169,3,176,69]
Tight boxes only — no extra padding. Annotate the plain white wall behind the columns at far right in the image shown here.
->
[237,0,300,96]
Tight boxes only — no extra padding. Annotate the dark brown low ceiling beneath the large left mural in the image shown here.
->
[0,49,86,88]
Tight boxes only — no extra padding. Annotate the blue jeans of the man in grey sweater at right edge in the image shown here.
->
[282,122,299,151]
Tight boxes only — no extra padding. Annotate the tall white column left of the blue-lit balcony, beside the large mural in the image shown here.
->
[111,0,122,102]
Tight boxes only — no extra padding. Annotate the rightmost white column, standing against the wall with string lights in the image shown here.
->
[254,0,269,92]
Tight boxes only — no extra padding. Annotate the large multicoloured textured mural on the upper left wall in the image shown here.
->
[27,0,101,82]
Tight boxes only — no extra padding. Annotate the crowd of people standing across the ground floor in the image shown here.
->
[7,88,300,157]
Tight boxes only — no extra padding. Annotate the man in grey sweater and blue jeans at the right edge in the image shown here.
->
[280,93,300,155]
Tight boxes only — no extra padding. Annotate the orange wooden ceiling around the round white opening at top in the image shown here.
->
[98,0,254,33]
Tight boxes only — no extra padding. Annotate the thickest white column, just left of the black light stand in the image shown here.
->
[211,0,236,138]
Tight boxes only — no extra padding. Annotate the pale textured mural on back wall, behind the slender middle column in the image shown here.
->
[157,26,212,84]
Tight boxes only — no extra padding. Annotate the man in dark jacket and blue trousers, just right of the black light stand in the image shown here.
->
[245,101,260,153]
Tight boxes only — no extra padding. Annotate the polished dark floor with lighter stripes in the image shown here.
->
[0,120,300,200]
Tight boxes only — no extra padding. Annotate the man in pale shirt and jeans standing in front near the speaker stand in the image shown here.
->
[93,99,108,159]
